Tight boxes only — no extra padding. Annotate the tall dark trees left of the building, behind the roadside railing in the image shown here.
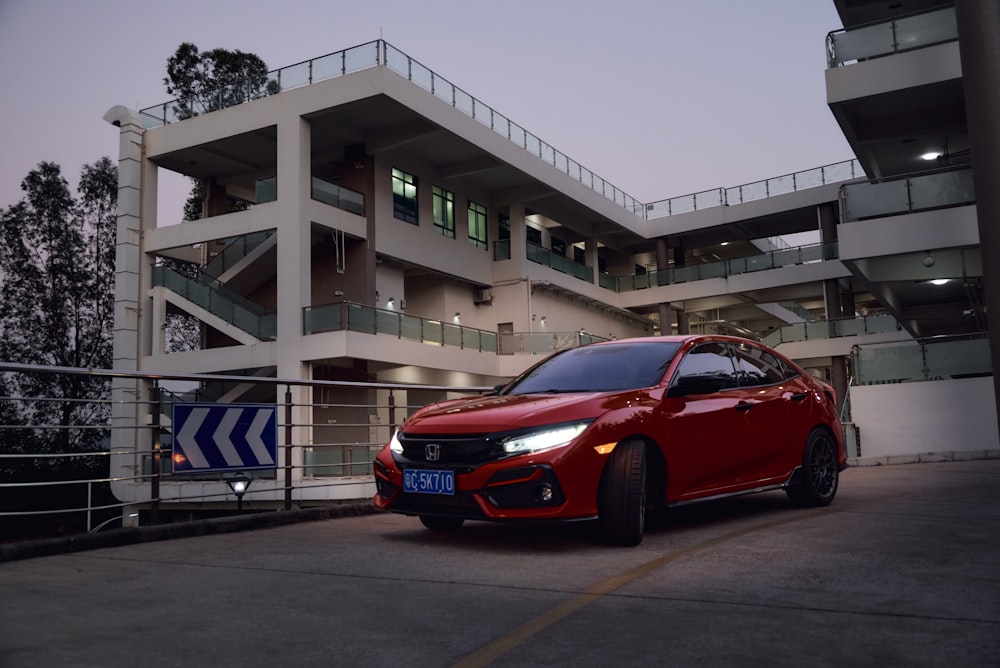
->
[0,158,118,480]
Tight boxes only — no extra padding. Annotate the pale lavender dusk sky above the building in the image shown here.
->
[0,0,853,219]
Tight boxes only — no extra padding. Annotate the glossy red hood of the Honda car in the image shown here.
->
[403,390,616,434]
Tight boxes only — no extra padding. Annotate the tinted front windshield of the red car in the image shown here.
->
[504,341,680,394]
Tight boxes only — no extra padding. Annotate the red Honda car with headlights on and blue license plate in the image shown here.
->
[374,335,847,545]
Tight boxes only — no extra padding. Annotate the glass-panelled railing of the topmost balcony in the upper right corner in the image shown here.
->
[826,7,958,68]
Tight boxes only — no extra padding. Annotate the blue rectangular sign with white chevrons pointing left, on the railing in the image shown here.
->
[172,403,278,473]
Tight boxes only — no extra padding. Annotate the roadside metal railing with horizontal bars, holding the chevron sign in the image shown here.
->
[0,363,489,541]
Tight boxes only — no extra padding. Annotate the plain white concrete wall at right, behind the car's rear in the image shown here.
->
[851,377,1000,463]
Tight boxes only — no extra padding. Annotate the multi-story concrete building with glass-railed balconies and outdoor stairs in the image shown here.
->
[106,0,997,512]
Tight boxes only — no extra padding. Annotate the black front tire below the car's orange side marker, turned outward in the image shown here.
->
[597,439,646,546]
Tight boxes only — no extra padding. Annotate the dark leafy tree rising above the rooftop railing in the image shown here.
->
[163,42,279,119]
